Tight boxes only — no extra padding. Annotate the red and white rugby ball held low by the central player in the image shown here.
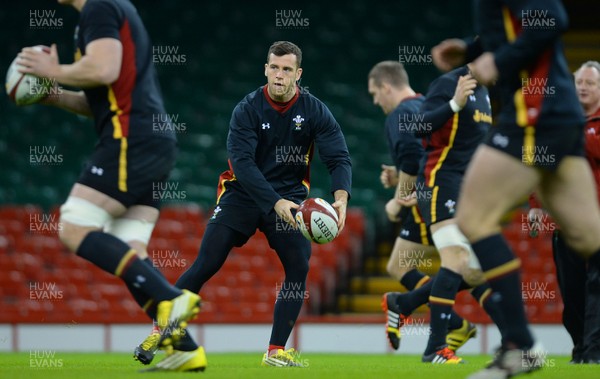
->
[296,197,338,244]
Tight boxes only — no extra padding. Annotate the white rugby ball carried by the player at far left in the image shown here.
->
[6,46,52,105]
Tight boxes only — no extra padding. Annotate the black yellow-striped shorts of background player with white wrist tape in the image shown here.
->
[417,172,463,227]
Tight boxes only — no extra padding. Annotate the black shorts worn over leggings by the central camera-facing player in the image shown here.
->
[208,203,311,256]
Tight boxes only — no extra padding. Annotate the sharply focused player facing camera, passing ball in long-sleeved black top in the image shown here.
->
[135,41,352,367]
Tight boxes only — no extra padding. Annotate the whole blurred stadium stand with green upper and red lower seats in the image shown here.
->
[0,0,600,323]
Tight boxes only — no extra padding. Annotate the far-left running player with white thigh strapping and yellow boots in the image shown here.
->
[19,0,206,371]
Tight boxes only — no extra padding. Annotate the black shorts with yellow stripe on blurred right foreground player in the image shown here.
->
[484,125,585,170]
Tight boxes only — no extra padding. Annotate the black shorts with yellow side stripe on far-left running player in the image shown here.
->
[77,138,176,208]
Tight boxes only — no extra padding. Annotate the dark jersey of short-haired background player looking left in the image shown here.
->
[385,95,425,176]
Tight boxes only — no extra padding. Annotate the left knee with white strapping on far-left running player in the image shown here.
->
[59,197,112,253]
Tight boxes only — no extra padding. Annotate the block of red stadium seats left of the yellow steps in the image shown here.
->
[0,205,364,323]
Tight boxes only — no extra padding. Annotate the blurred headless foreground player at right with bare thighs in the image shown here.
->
[432,0,600,379]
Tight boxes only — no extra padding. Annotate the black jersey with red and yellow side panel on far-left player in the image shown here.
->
[75,0,175,139]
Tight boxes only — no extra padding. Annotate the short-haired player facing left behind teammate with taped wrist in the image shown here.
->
[368,61,477,351]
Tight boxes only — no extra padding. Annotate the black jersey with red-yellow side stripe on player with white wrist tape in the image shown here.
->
[417,66,492,187]
